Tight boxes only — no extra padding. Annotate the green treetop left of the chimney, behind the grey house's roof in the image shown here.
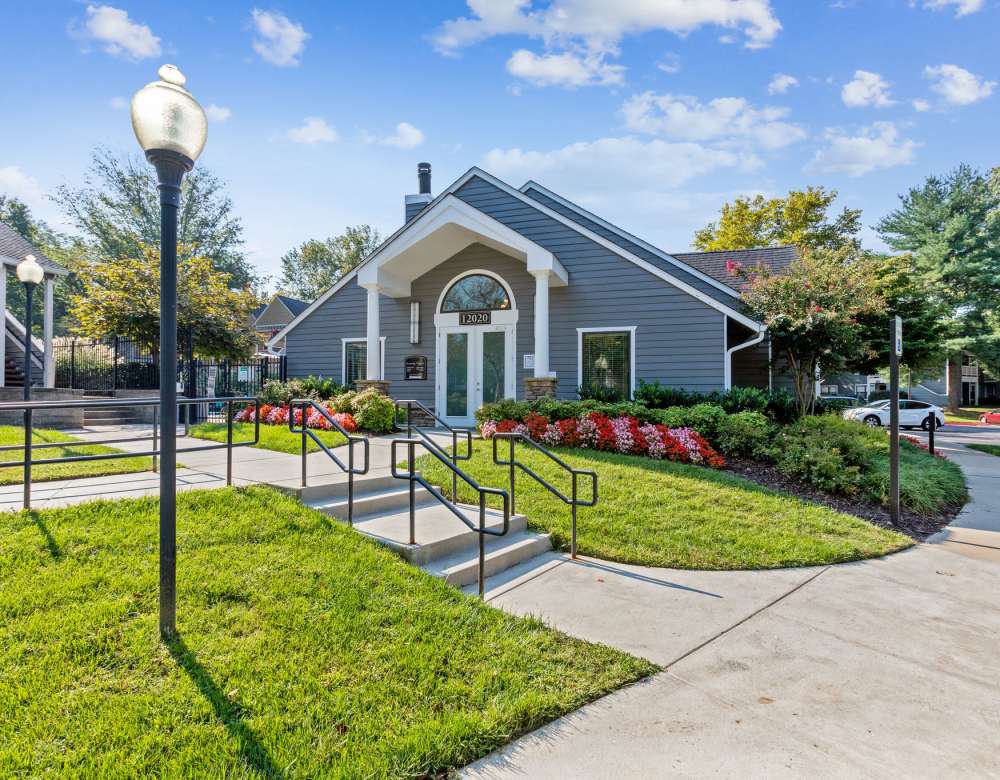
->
[281,225,382,301]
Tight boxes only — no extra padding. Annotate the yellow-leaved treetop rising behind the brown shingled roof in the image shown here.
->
[694,187,861,251]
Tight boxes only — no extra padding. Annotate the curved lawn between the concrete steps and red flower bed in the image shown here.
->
[418,441,913,569]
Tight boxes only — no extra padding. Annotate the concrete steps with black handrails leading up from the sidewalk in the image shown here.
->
[300,476,552,587]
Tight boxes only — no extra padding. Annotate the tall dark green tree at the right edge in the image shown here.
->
[878,165,1000,408]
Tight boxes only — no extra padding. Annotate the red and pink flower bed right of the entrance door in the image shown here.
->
[479,412,725,469]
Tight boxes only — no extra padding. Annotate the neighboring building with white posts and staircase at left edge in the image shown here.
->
[0,222,69,387]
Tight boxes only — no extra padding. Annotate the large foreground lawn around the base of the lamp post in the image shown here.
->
[0,488,656,778]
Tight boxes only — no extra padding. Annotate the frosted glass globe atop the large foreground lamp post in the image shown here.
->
[132,65,208,163]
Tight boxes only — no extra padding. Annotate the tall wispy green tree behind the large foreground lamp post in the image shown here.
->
[54,148,256,288]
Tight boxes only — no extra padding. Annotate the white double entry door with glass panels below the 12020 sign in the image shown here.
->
[436,325,516,426]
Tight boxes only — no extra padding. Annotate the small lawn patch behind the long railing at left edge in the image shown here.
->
[0,425,153,485]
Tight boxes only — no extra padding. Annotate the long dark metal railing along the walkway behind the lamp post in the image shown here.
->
[0,396,260,509]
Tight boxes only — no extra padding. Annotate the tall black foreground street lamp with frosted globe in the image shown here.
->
[132,65,208,637]
